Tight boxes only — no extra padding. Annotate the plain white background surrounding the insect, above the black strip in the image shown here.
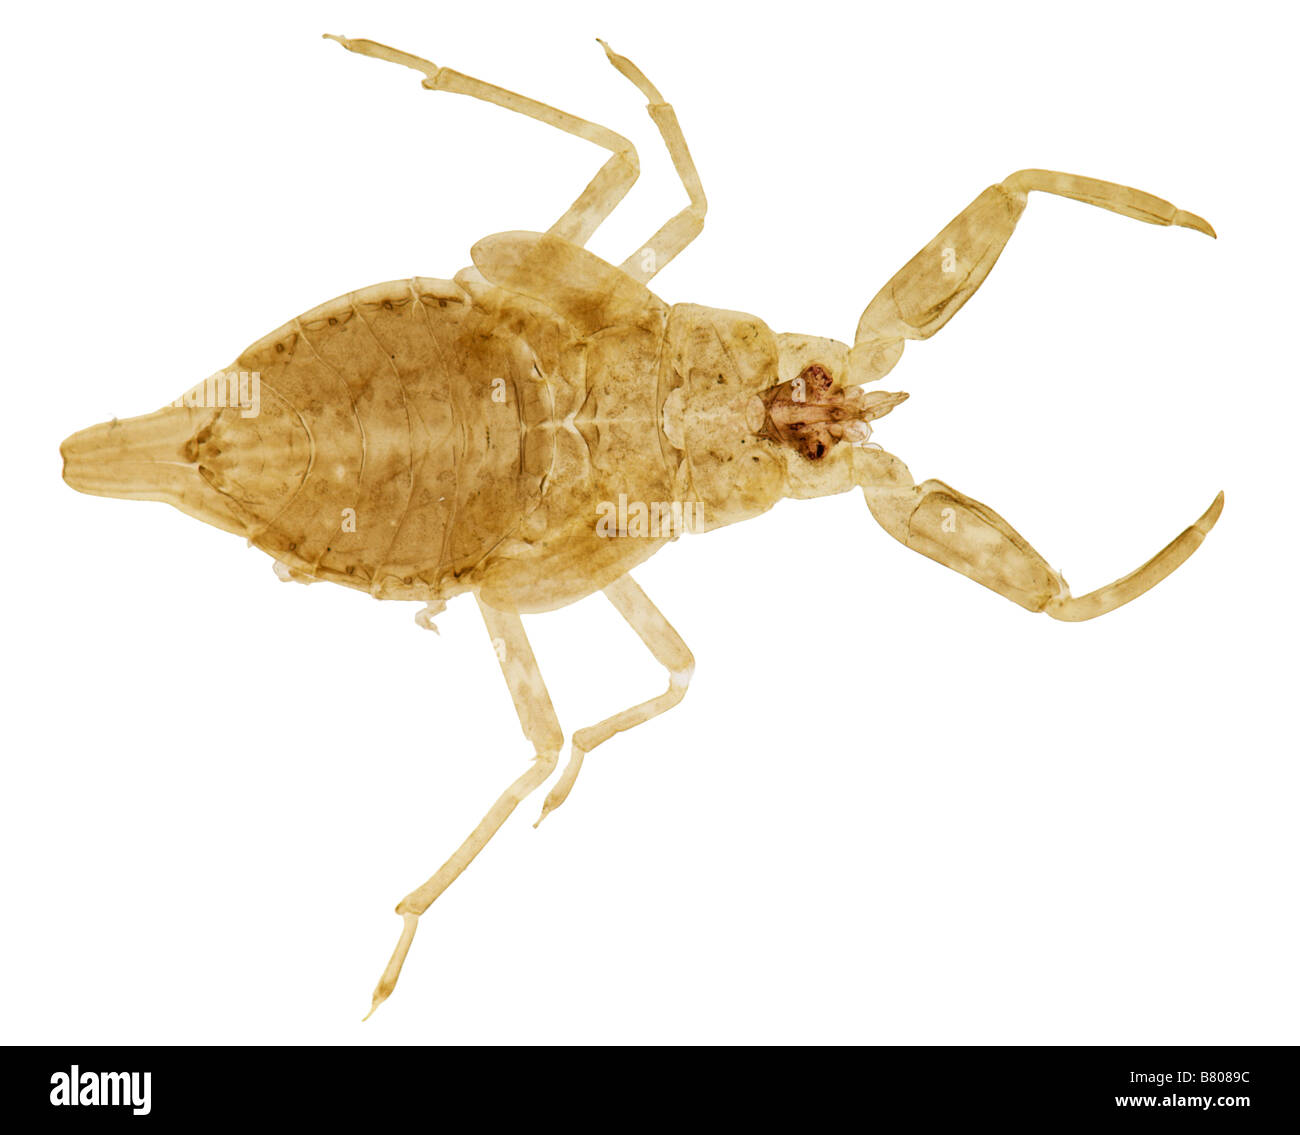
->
[0,0,1300,1044]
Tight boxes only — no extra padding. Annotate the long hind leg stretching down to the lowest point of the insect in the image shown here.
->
[365,599,564,1017]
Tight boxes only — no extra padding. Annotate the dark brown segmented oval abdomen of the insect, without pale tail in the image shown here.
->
[234,278,580,599]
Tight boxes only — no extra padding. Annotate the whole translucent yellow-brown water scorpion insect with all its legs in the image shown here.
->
[62,36,1223,1011]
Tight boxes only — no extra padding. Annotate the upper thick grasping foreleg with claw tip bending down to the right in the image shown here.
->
[848,169,1214,385]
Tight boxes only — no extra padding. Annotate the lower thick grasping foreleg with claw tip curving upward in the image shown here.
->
[854,449,1223,623]
